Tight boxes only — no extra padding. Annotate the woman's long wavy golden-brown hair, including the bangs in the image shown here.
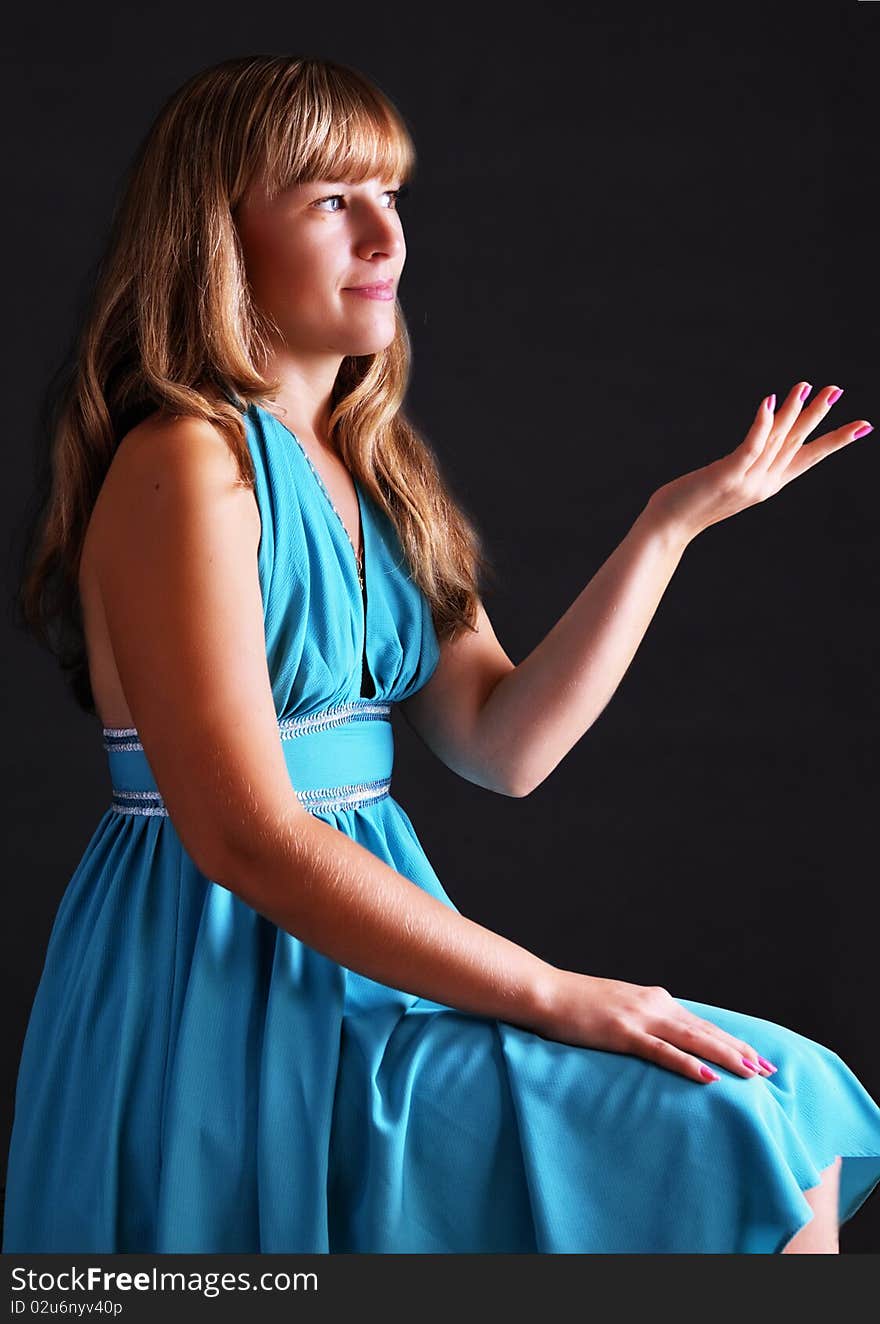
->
[16,56,495,715]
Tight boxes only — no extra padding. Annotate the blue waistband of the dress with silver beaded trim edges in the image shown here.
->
[102,699,393,817]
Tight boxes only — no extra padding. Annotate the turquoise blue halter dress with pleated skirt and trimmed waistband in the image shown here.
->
[3,405,880,1254]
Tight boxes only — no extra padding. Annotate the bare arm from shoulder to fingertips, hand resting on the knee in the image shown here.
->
[93,416,767,1080]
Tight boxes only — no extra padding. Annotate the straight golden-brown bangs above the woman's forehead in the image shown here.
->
[260,65,416,195]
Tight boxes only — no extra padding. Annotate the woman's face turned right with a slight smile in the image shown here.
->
[236,179,406,357]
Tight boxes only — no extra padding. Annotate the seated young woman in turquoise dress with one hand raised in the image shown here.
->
[3,57,880,1253]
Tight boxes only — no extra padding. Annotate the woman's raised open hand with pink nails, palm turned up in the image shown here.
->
[651,381,872,538]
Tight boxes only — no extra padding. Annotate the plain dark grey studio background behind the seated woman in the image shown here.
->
[0,0,880,1251]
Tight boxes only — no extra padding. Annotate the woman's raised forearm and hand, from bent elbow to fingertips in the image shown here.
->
[478,383,871,796]
